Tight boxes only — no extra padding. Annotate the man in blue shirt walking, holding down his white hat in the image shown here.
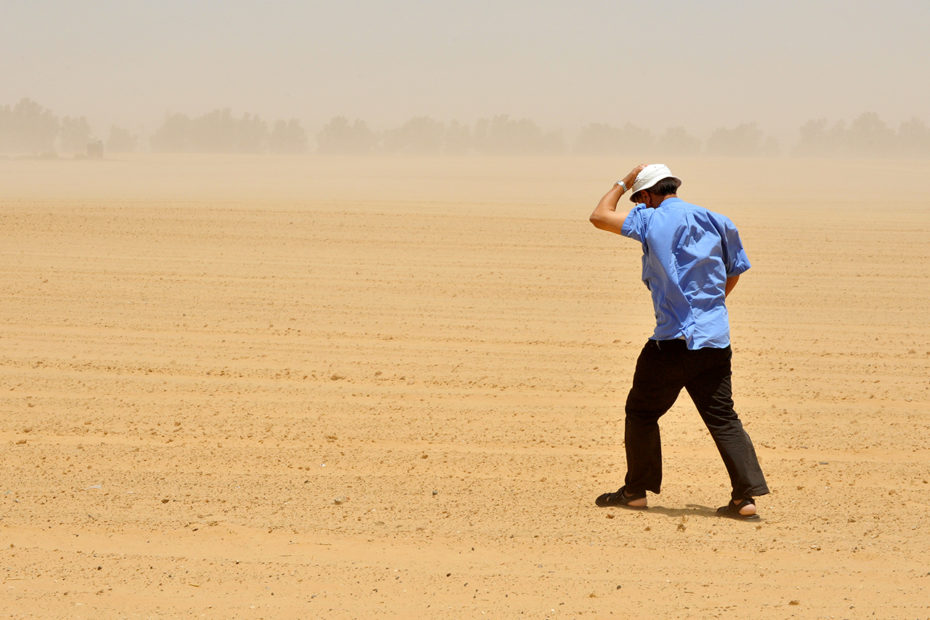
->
[590,164,769,520]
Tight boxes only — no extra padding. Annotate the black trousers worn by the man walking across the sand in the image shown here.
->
[624,340,769,500]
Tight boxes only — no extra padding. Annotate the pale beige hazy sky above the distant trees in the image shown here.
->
[0,0,930,135]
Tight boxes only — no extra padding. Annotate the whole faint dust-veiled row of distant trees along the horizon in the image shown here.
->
[0,99,930,157]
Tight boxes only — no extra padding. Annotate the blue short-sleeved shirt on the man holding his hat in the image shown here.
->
[621,198,750,349]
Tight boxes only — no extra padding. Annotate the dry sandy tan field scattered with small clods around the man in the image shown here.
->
[0,157,930,618]
